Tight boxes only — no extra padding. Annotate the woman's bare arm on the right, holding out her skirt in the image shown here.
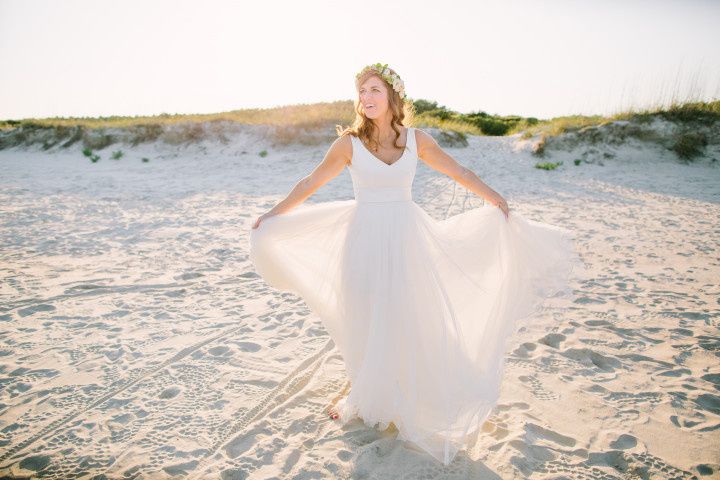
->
[415,128,509,217]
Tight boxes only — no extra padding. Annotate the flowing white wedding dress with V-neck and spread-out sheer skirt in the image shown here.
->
[250,128,581,465]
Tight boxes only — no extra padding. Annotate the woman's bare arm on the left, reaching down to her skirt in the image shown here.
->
[253,135,352,228]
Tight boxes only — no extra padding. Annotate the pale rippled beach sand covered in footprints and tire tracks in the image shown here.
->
[0,125,720,479]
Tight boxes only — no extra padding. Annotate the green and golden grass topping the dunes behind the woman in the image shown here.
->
[0,95,720,150]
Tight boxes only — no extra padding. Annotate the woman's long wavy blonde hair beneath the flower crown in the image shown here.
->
[335,68,415,159]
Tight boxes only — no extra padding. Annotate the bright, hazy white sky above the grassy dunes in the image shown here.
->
[0,0,720,120]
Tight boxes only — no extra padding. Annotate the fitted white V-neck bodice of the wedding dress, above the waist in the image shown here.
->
[348,127,418,202]
